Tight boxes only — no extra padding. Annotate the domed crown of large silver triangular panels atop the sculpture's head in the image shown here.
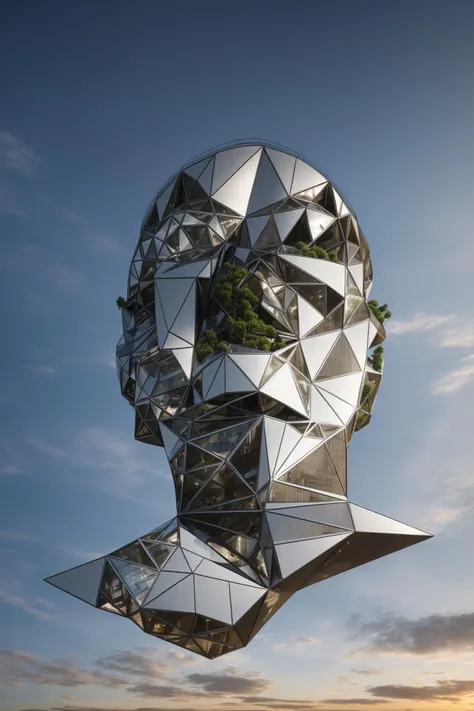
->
[139,145,350,237]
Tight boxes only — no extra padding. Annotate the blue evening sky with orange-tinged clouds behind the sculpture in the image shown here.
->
[0,0,474,711]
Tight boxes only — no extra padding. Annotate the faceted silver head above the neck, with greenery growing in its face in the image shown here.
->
[117,144,385,500]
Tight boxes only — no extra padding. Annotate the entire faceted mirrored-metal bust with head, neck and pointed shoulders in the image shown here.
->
[47,143,429,658]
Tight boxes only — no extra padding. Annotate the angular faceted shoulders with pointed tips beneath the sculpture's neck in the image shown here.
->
[46,501,431,659]
